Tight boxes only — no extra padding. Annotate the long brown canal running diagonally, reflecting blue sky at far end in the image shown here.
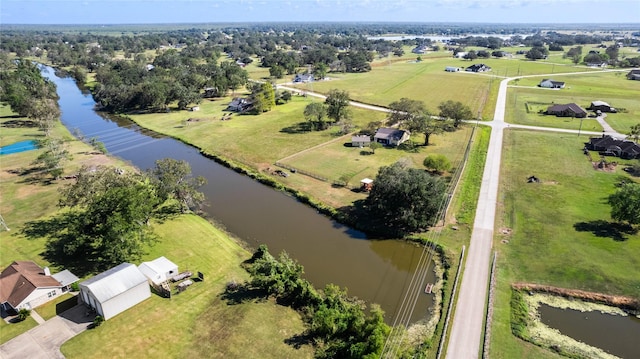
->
[42,67,435,324]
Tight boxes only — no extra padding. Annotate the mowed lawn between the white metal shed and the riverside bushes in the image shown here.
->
[62,215,313,358]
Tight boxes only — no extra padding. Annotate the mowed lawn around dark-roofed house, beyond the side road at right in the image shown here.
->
[507,71,640,133]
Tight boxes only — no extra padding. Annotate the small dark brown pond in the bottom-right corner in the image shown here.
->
[538,304,640,358]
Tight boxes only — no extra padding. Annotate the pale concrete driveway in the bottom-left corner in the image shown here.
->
[0,304,94,359]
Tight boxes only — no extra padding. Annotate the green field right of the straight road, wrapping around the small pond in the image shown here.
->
[491,131,640,358]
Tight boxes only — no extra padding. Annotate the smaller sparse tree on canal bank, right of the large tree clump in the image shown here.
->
[149,158,207,213]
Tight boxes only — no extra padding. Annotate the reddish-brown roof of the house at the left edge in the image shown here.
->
[0,261,61,308]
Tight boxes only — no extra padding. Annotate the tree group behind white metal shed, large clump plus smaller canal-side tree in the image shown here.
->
[24,159,205,273]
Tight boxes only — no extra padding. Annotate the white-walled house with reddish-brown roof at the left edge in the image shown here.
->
[0,261,79,312]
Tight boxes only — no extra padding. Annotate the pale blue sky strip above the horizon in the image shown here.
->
[0,0,640,25]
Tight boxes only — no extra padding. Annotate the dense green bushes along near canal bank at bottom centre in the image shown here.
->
[238,245,390,359]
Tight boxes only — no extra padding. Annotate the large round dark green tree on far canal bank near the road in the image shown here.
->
[365,162,446,235]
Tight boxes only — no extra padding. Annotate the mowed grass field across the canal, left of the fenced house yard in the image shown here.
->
[131,95,386,167]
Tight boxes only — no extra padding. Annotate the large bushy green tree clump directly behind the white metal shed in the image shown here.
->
[24,167,160,273]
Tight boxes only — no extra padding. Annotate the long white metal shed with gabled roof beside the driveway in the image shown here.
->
[79,263,151,320]
